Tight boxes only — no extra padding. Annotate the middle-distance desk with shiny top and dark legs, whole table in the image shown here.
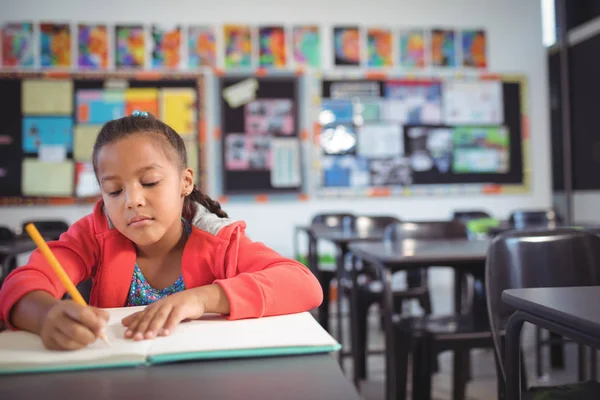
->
[349,239,489,399]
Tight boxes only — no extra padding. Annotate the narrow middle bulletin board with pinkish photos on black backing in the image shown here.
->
[215,70,307,201]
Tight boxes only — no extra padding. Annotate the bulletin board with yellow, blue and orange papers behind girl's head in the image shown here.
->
[0,72,206,205]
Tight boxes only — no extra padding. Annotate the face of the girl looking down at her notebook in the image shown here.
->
[97,134,193,246]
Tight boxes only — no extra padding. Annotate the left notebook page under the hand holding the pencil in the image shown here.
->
[0,307,151,374]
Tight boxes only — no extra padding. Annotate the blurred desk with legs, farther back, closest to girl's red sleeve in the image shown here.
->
[297,225,384,363]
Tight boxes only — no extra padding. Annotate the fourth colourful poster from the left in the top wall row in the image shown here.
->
[115,25,146,68]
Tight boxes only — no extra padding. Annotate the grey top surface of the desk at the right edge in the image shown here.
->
[502,286,600,337]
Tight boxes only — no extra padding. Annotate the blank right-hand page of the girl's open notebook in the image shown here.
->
[150,312,338,356]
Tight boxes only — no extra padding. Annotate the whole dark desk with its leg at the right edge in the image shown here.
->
[502,286,600,400]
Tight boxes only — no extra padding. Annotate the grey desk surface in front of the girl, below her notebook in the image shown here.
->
[0,354,359,400]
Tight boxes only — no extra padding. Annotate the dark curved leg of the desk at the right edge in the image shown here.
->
[504,311,524,400]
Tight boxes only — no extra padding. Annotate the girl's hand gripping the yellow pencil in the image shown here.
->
[40,300,108,350]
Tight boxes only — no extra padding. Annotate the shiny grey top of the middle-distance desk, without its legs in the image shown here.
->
[349,239,489,268]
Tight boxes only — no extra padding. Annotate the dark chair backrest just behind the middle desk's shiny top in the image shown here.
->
[385,221,468,241]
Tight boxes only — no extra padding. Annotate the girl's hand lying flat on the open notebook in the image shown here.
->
[122,287,206,340]
